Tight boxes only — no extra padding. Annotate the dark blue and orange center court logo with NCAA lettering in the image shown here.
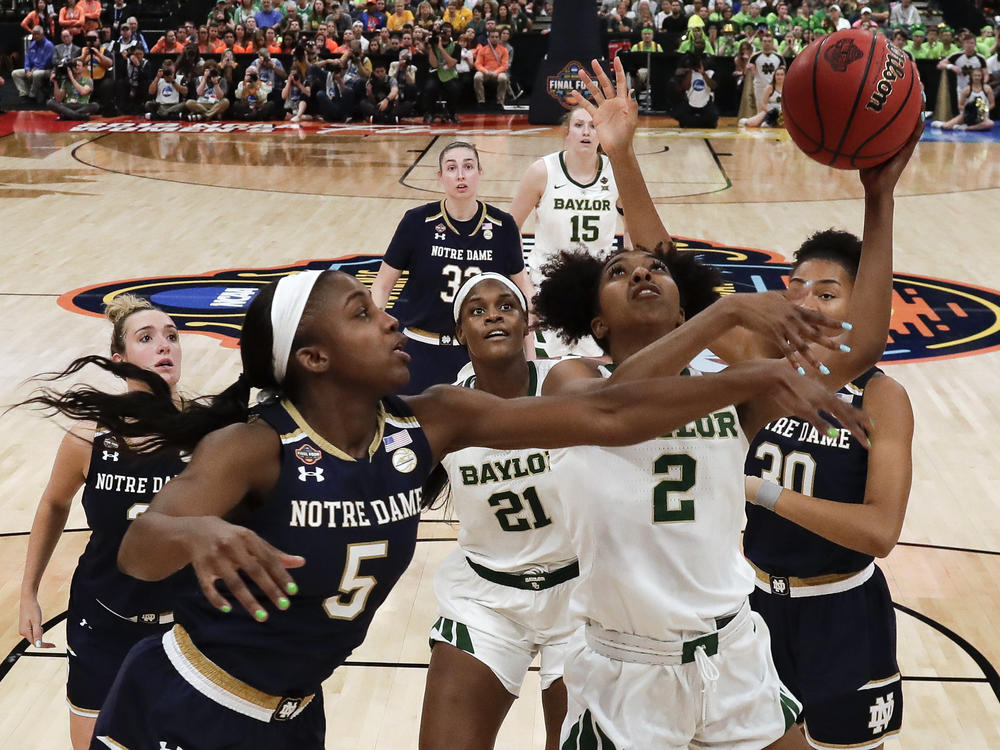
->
[59,235,1000,363]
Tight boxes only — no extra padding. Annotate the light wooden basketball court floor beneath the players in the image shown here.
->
[0,114,1000,750]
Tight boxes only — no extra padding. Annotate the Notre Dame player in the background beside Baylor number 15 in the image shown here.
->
[372,141,534,394]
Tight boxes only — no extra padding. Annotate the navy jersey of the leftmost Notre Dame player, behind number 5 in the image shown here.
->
[71,428,184,622]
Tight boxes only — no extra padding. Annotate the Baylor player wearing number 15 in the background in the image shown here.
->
[510,107,620,357]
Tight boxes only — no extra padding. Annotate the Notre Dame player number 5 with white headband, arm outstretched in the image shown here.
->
[25,268,864,750]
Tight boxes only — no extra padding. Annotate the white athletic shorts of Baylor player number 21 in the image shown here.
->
[430,549,581,696]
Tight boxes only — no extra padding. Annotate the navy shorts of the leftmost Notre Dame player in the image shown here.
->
[66,602,171,717]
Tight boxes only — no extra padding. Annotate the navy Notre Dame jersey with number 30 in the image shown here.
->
[743,367,882,578]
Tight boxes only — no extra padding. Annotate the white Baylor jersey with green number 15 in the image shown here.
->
[528,151,618,281]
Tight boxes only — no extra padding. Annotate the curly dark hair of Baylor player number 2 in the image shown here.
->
[534,244,722,352]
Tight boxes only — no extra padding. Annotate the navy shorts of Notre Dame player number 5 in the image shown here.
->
[90,638,326,750]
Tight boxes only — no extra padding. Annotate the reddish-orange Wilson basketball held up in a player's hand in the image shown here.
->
[781,29,924,169]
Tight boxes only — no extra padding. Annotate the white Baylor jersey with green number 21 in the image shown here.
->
[441,359,576,573]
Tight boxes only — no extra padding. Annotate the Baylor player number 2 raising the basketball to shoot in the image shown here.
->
[535,61,920,750]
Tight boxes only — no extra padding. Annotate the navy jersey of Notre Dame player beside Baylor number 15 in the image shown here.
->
[383,201,524,334]
